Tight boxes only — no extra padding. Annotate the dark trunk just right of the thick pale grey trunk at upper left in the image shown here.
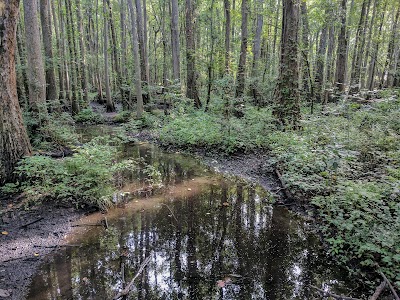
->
[40,0,57,100]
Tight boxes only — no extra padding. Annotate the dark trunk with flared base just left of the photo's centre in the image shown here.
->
[186,0,202,108]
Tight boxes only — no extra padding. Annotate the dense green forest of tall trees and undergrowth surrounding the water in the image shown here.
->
[0,0,400,299]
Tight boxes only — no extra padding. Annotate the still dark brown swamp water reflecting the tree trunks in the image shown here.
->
[28,129,357,300]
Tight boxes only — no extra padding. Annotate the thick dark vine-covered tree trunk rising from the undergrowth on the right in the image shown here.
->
[274,0,300,129]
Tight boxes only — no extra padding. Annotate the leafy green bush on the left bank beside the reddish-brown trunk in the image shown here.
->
[11,138,140,209]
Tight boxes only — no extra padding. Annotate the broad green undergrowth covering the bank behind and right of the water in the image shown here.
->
[149,91,400,288]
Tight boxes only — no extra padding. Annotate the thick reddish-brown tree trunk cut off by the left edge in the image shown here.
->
[0,0,31,185]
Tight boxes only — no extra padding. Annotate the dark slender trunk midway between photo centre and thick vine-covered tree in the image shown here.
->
[235,0,249,98]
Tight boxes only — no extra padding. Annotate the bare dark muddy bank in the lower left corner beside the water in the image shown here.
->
[0,199,83,300]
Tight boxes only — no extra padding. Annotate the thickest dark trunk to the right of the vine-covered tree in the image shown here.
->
[335,0,347,92]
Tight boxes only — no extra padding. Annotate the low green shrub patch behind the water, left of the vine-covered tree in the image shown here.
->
[159,108,272,153]
